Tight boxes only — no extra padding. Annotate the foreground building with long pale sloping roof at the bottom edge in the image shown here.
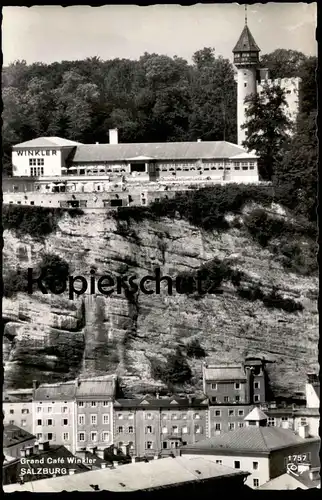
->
[4,457,248,492]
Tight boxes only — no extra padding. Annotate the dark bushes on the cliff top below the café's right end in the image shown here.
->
[115,184,317,275]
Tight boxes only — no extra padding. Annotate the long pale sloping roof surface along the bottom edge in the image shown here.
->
[3,457,249,493]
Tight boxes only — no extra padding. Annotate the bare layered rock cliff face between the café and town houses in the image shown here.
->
[3,213,318,396]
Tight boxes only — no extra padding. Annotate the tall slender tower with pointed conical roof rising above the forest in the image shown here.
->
[233,11,260,146]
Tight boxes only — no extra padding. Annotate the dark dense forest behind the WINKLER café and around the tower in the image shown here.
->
[2,47,317,220]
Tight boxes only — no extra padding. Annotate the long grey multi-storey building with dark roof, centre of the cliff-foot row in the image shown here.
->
[114,396,209,457]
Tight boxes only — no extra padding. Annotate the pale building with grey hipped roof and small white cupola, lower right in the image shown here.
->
[181,407,320,488]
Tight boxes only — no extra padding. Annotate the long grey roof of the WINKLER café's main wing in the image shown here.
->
[70,141,252,163]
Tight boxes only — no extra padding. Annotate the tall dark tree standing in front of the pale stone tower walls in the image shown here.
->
[242,84,292,180]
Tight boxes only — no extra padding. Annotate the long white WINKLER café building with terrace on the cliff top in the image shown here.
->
[3,130,258,209]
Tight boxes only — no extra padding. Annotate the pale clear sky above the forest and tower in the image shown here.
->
[2,2,317,66]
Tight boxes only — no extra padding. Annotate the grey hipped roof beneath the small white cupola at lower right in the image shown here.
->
[181,426,319,453]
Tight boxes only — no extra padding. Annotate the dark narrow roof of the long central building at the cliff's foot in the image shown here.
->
[114,396,208,410]
